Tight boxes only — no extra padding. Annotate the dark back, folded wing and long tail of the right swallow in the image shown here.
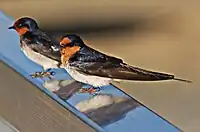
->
[69,47,190,82]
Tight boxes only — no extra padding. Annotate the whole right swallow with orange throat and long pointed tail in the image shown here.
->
[60,34,191,91]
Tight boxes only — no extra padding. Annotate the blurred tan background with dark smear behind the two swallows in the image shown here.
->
[0,0,200,132]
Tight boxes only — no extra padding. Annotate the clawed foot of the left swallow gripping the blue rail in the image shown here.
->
[30,69,56,79]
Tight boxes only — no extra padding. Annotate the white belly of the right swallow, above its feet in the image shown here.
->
[65,64,112,87]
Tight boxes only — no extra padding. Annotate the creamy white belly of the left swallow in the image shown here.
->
[21,44,58,69]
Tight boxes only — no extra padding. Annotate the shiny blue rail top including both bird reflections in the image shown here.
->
[0,13,180,132]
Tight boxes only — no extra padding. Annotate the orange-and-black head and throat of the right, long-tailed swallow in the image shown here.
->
[60,35,85,65]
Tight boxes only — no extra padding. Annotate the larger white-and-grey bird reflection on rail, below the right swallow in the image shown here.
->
[76,94,140,126]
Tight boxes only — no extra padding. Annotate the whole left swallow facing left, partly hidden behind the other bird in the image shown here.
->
[8,17,61,77]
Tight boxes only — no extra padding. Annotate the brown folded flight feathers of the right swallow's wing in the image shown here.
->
[71,61,177,81]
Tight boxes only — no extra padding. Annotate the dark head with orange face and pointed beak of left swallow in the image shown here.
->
[8,17,39,36]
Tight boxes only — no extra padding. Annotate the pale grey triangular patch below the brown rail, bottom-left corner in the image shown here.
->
[0,117,19,132]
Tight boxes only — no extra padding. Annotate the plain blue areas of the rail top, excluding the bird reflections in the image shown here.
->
[0,12,179,132]
